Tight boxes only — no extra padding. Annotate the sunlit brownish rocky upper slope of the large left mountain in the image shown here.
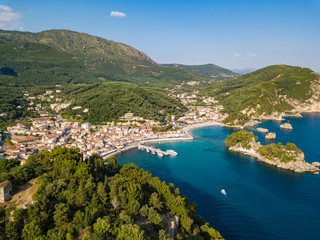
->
[0,30,157,70]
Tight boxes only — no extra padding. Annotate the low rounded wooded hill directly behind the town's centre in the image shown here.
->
[61,82,187,124]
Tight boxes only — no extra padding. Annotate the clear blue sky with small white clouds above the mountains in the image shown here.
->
[0,0,320,72]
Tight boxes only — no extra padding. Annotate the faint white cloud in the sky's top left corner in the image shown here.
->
[0,5,22,30]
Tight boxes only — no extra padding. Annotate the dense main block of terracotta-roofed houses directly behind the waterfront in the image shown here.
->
[1,117,188,160]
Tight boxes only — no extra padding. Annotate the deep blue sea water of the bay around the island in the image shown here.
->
[118,114,320,240]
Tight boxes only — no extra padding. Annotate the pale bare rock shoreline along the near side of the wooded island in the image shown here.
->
[229,144,320,174]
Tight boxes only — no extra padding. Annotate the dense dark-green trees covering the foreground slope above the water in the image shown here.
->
[0,148,222,240]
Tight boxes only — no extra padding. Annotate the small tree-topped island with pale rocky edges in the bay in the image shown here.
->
[225,130,320,174]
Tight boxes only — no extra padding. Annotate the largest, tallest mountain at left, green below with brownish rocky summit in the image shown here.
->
[0,30,209,87]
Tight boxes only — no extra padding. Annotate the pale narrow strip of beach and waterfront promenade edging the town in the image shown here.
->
[102,121,225,161]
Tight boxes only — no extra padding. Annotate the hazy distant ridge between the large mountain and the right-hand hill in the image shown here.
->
[161,63,239,79]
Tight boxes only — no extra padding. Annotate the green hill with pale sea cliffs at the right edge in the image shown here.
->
[208,65,320,123]
